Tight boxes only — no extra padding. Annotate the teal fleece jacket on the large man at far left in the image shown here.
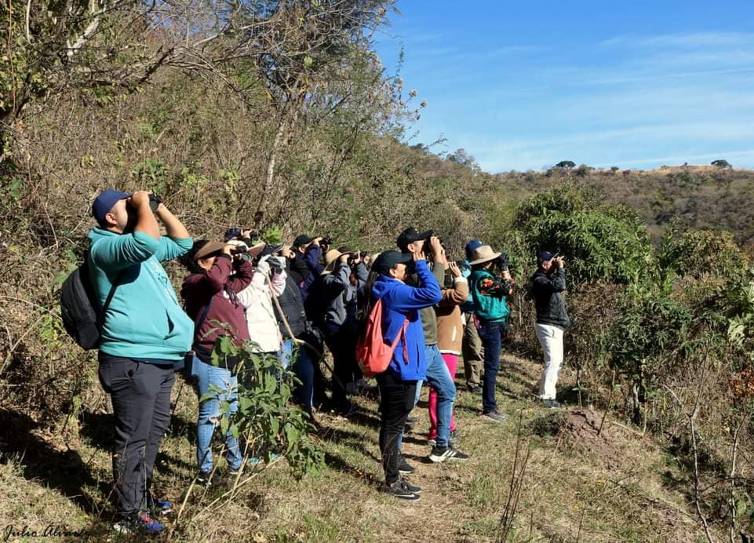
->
[87,226,194,362]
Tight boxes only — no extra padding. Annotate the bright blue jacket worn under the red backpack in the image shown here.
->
[372,260,442,381]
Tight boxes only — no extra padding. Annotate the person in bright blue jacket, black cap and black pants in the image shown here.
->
[372,251,442,501]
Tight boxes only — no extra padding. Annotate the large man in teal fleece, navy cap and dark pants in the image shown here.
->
[88,190,194,533]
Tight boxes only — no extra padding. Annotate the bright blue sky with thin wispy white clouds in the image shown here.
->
[377,0,754,172]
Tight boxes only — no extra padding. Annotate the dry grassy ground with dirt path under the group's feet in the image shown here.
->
[0,355,716,542]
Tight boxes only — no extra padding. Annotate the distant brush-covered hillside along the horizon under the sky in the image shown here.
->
[408,150,754,244]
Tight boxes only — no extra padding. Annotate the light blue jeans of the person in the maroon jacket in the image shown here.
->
[191,357,241,472]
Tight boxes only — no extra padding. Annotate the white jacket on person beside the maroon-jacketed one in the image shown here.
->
[238,259,286,353]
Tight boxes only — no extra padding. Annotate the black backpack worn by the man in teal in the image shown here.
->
[60,253,120,351]
